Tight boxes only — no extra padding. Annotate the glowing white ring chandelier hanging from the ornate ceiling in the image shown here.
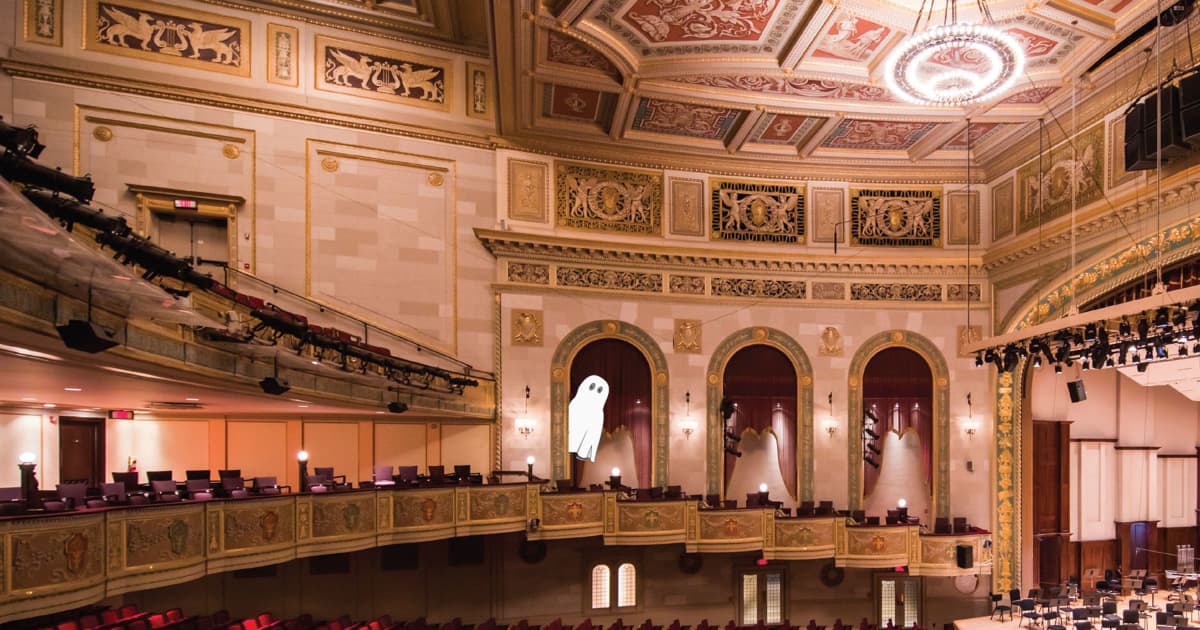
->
[884,24,1025,107]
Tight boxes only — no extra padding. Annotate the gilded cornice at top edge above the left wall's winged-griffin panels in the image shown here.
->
[206,0,490,59]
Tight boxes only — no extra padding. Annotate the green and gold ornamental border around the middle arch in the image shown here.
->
[707,326,812,500]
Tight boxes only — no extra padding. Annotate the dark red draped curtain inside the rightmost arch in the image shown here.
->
[863,348,934,494]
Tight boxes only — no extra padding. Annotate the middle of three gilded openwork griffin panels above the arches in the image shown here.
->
[709,179,804,244]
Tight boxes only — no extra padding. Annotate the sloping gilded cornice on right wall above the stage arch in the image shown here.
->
[983,164,1200,271]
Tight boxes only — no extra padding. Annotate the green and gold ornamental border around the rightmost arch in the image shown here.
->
[846,330,950,518]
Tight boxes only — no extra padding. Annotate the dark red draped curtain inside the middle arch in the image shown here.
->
[725,344,797,498]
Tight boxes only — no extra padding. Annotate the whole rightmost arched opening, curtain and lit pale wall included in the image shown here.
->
[863,347,934,521]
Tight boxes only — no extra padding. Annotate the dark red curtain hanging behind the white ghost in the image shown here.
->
[571,340,654,487]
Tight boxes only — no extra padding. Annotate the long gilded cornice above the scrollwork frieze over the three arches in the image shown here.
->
[475,228,984,273]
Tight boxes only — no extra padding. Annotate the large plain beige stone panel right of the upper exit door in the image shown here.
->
[305,140,458,352]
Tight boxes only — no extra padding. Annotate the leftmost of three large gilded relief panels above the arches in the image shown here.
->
[554,162,662,236]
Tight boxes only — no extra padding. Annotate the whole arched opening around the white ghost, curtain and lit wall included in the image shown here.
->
[570,338,653,487]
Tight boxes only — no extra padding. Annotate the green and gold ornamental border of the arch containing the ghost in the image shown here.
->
[550,319,671,486]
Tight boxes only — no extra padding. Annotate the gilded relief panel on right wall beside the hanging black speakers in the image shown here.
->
[1016,122,1104,232]
